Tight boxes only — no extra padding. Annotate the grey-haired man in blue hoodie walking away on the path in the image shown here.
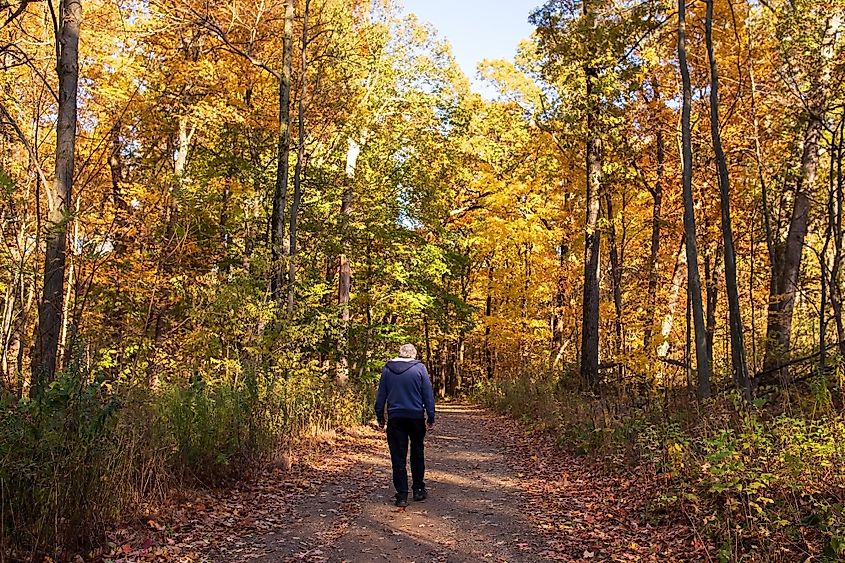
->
[376,344,434,507]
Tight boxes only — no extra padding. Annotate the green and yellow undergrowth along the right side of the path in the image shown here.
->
[478,368,845,561]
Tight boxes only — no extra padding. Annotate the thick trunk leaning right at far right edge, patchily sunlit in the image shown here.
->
[764,13,841,368]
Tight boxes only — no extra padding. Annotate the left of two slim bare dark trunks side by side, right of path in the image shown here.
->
[678,0,710,397]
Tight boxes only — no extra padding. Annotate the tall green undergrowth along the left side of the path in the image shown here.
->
[0,360,370,560]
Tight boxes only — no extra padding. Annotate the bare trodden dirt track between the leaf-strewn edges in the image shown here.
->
[247,404,553,563]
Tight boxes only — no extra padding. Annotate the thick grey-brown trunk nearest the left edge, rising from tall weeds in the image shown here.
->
[30,0,82,397]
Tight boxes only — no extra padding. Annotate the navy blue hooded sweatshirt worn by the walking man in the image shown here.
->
[376,358,434,424]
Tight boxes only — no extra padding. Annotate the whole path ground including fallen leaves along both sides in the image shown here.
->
[106,404,709,563]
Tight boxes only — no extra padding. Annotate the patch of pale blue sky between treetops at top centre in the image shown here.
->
[404,0,543,93]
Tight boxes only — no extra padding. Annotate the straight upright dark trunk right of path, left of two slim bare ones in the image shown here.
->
[581,59,602,391]
